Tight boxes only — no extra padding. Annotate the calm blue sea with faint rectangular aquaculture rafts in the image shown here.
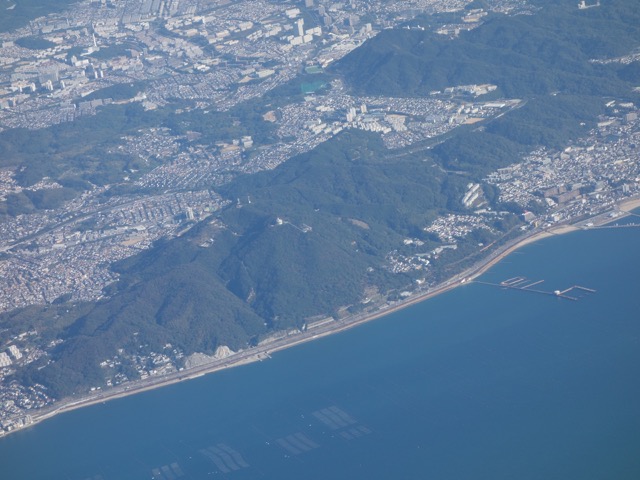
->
[0,228,640,480]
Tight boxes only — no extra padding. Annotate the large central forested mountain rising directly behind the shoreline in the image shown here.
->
[3,132,480,395]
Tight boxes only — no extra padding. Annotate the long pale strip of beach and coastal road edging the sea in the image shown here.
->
[0,198,640,439]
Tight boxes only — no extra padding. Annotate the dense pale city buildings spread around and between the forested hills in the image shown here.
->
[0,0,640,435]
